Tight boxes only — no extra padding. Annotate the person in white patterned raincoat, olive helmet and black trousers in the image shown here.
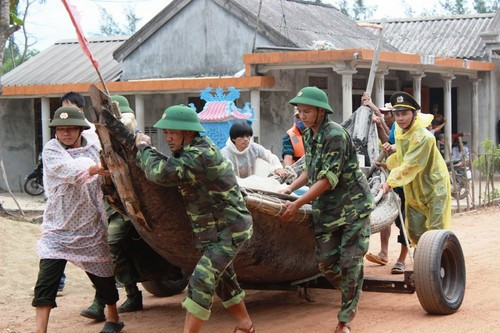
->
[32,106,124,333]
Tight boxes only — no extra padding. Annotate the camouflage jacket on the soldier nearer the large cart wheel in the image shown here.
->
[304,119,375,233]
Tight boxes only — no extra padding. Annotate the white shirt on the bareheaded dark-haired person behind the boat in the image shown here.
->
[221,138,283,178]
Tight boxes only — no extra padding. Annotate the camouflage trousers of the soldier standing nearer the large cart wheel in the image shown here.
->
[315,218,370,323]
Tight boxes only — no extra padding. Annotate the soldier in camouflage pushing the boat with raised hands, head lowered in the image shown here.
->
[135,105,255,332]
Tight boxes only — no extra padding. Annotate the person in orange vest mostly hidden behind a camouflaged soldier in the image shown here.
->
[281,107,306,167]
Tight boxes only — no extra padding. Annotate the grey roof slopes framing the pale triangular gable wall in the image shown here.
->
[114,0,397,59]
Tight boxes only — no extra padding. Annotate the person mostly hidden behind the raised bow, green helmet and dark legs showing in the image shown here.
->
[80,95,143,321]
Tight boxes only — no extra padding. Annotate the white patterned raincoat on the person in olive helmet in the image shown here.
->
[37,133,113,277]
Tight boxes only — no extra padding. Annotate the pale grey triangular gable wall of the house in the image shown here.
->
[122,0,273,81]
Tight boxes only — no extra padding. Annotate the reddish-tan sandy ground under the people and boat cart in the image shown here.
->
[0,207,500,333]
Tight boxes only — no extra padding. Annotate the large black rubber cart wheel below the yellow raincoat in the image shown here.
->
[414,230,465,314]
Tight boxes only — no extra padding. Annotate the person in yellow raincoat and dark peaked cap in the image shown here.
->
[382,91,451,246]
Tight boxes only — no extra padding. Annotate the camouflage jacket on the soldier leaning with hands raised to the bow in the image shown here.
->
[136,136,252,247]
